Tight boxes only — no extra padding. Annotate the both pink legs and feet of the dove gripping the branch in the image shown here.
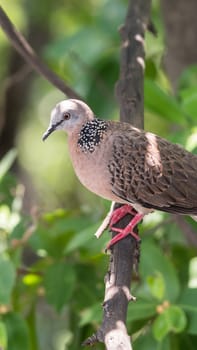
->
[107,205,144,249]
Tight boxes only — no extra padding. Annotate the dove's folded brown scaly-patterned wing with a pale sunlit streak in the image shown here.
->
[108,123,197,214]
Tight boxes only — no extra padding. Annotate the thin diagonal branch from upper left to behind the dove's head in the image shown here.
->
[0,6,82,100]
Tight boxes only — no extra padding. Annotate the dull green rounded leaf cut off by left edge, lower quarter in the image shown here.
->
[0,256,16,304]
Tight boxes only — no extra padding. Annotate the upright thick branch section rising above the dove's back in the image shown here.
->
[116,0,151,128]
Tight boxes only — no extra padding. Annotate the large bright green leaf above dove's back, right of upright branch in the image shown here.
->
[144,79,186,125]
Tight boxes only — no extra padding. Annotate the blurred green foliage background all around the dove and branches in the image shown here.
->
[0,0,197,350]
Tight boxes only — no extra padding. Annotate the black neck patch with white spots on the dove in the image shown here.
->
[78,119,108,153]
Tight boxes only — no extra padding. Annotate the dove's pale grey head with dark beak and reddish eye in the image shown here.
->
[42,99,94,141]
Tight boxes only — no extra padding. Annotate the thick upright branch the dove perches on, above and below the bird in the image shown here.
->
[84,0,151,350]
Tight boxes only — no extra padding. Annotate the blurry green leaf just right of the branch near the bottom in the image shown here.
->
[128,300,156,322]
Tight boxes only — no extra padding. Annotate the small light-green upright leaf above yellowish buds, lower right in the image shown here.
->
[147,272,165,300]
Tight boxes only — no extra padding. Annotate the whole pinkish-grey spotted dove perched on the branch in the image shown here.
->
[43,99,197,248]
